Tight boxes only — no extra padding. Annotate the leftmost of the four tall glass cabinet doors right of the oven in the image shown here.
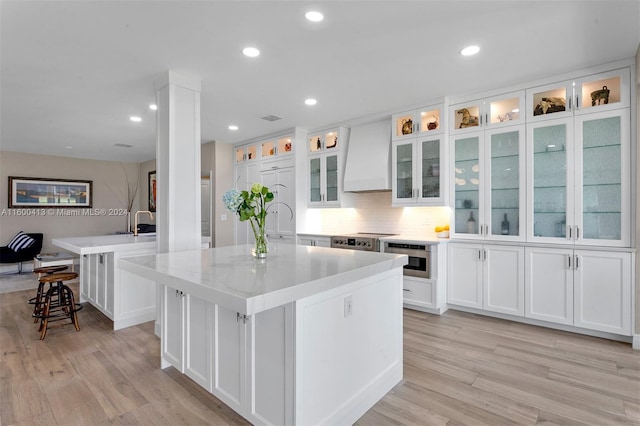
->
[451,133,484,238]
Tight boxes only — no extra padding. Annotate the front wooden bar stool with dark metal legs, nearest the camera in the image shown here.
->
[34,272,82,340]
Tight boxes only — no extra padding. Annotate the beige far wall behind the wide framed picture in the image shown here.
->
[0,151,140,252]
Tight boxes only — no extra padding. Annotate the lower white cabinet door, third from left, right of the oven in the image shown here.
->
[525,247,573,325]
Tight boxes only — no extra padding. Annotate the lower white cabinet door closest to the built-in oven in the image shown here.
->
[447,243,482,309]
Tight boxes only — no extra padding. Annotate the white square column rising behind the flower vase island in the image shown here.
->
[155,71,201,253]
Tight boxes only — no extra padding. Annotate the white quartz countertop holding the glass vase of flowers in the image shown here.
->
[119,243,408,315]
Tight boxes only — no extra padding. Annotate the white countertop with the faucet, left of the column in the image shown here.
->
[51,233,156,255]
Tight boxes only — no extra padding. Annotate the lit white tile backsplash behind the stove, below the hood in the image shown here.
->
[298,191,450,236]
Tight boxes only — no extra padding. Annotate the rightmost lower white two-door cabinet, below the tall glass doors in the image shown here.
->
[525,247,632,336]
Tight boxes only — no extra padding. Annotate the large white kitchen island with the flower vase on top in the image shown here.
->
[119,244,407,425]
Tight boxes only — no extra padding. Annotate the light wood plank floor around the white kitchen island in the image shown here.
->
[0,288,640,426]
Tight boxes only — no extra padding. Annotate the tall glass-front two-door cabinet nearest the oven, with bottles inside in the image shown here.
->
[452,125,526,241]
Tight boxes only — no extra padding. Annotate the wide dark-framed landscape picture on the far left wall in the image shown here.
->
[8,176,93,209]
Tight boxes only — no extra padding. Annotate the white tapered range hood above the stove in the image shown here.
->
[343,118,391,192]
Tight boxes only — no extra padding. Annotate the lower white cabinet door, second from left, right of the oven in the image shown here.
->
[483,245,524,316]
